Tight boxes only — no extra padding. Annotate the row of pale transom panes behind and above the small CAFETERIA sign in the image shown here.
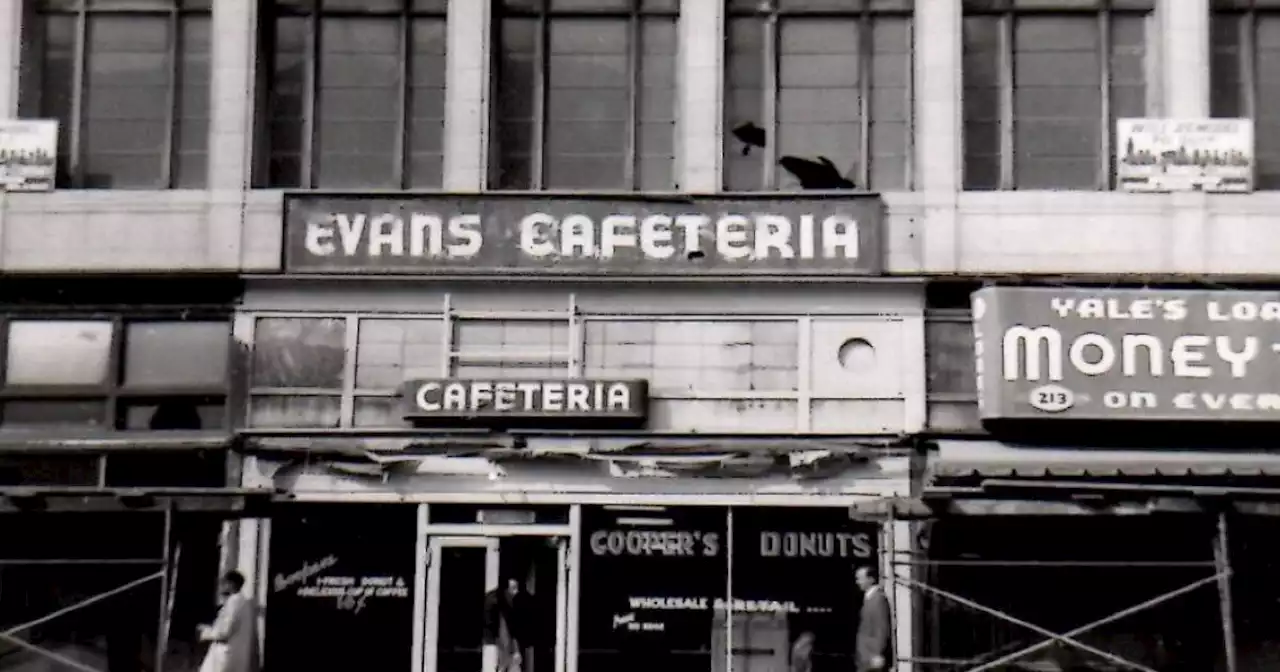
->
[250,314,800,428]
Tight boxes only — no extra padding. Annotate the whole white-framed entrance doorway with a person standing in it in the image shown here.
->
[424,535,568,672]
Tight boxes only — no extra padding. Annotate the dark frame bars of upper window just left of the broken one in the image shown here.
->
[483,0,680,193]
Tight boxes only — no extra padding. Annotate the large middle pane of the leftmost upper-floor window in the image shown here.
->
[81,14,173,188]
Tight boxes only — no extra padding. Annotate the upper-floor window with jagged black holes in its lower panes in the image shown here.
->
[724,0,911,191]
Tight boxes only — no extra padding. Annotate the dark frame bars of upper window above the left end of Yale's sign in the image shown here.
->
[960,0,1156,191]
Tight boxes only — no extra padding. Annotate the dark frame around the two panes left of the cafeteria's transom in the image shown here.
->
[0,308,236,431]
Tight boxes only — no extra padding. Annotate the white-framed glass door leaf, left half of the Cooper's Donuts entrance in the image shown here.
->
[424,536,499,672]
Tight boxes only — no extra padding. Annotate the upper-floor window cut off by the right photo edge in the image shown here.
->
[1210,0,1280,189]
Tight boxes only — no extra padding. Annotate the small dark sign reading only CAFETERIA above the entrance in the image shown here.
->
[404,379,648,420]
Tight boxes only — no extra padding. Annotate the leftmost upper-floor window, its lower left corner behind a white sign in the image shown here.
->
[18,0,211,189]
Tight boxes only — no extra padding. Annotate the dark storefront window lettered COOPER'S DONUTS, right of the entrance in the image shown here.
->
[579,507,878,672]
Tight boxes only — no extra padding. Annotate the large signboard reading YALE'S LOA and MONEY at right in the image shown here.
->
[973,287,1280,421]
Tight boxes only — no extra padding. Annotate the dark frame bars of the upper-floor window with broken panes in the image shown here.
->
[719,0,936,192]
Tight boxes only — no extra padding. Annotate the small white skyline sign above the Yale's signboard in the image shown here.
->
[1116,119,1253,193]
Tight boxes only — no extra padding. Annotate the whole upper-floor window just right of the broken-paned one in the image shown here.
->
[964,0,1152,189]
